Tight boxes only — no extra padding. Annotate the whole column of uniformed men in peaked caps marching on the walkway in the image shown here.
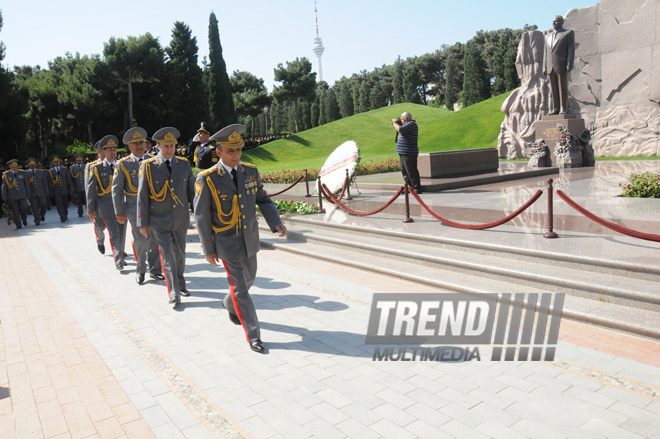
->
[2,122,287,353]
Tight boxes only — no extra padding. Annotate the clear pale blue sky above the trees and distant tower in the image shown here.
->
[0,0,598,91]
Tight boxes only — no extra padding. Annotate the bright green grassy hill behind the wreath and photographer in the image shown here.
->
[242,93,508,172]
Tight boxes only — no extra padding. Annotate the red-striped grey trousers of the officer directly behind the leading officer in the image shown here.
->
[149,227,188,298]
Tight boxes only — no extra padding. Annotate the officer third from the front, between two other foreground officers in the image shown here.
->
[112,127,165,285]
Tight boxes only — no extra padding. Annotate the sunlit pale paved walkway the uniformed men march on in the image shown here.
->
[0,162,660,439]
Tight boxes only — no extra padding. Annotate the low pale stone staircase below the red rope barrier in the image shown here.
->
[261,217,660,339]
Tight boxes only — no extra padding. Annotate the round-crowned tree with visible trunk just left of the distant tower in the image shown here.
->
[273,57,316,132]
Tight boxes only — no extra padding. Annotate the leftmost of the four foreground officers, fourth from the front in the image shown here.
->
[85,134,126,271]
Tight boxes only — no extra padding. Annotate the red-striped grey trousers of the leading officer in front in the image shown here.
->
[222,255,261,341]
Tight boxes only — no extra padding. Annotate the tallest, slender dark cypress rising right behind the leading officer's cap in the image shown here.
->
[206,12,236,129]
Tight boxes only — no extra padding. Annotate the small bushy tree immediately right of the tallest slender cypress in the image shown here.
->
[229,70,272,136]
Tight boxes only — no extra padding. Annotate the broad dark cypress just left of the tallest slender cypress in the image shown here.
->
[161,21,208,137]
